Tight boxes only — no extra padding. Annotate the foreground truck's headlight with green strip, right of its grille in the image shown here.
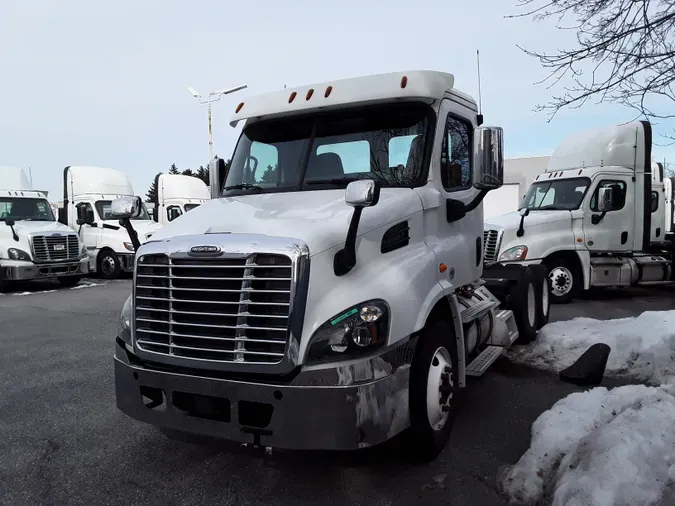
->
[307,300,389,363]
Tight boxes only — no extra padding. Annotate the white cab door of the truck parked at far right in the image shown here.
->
[583,173,635,253]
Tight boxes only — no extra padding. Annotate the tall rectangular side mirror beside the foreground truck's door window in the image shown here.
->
[473,126,504,190]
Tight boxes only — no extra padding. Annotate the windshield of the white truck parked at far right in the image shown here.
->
[520,177,590,211]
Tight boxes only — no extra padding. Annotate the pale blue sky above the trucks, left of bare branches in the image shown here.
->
[0,0,675,200]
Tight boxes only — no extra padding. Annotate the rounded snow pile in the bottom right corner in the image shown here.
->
[499,384,675,506]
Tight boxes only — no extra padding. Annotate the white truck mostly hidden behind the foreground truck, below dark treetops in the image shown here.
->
[152,174,211,225]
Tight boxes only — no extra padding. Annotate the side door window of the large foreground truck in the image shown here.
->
[441,115,472,191]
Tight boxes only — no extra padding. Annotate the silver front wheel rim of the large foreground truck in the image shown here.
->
[427,346,455,431]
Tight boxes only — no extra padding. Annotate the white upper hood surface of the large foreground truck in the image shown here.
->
[147,188,422,255]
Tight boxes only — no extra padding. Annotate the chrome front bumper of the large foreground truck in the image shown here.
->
[115,339,415,450]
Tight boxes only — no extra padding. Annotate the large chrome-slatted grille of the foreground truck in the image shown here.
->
[134,253,293,364]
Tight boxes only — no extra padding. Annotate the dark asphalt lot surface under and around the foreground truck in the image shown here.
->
[0,280,675,506]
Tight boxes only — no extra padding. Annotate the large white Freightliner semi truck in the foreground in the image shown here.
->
[113,71,549,459]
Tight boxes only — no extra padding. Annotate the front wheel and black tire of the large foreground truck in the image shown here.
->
[407,320,458,462]
